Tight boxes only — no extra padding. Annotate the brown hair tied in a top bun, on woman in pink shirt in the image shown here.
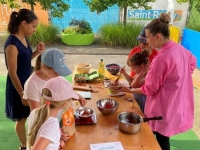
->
[146,13,171,38]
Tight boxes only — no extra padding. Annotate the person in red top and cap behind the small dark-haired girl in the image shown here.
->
[127,27,158,77]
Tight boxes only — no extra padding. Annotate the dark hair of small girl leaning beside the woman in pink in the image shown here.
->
[129,50,149,66]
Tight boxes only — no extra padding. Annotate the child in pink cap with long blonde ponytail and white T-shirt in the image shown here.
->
[28,76,79,150]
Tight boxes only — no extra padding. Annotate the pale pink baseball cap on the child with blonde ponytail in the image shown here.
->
[42,76,79,101]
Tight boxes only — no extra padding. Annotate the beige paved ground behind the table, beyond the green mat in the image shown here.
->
[0,39,200,138]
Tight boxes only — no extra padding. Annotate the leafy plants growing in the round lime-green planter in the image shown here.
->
[63,19,92,34]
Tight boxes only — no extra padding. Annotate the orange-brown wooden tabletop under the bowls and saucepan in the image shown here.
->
[62,74,161,150]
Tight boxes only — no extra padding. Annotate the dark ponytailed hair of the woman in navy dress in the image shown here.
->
[8,9,38,34]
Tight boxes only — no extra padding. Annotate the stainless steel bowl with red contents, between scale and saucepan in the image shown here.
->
[96,98,119,115]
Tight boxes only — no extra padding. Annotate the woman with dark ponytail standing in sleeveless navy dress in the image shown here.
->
[4,9,45,150]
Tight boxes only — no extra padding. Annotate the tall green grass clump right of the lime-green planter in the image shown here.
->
[99,23,144,47]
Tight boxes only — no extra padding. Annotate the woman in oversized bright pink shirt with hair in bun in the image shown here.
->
[116,13,196,150]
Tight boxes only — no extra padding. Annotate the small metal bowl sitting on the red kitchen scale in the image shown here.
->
[74,107,94,119]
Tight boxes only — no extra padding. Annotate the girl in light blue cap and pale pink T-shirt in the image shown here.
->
[23,48,86,148]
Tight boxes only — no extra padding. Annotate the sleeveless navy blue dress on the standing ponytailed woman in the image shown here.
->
[4,35,32,121]
